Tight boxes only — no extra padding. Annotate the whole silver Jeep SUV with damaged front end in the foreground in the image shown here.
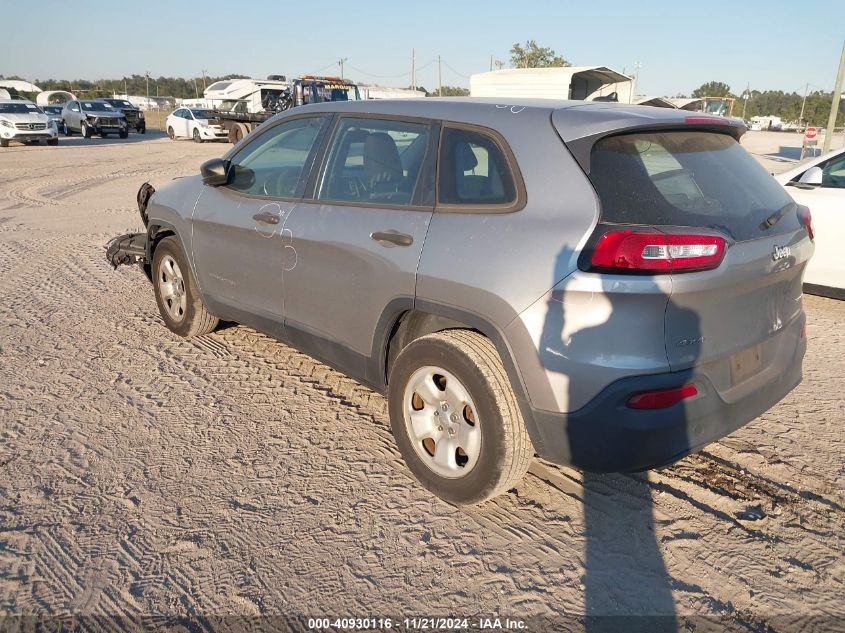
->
[107,99,813,504]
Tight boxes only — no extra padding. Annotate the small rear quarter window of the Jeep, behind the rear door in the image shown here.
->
[437,127,517,206]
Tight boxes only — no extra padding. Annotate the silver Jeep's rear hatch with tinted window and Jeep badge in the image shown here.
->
[576,126,813,401]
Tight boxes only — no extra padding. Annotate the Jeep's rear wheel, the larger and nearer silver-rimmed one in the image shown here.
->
[388,330,534,505]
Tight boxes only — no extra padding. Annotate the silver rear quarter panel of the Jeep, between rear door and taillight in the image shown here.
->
[416,104,598,408]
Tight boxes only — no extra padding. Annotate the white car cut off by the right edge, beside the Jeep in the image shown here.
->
[775,148,845,299]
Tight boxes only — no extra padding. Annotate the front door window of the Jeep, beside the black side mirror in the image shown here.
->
[228,116,326,198]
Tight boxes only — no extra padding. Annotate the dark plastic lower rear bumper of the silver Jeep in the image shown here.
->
[533,338,807,472]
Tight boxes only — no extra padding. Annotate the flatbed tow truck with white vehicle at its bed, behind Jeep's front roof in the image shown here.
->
[203,75,361,143]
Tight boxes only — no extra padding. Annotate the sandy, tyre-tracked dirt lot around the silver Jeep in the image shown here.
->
[0,133,845,631]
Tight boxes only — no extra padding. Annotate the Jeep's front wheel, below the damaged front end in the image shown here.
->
[152,236,219,338]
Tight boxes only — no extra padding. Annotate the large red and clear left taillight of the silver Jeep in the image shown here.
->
[590,230,725,273]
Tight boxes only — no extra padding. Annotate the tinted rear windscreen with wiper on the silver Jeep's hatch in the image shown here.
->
[590,131,800,241]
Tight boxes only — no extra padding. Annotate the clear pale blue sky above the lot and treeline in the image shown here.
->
[0,0,845,95]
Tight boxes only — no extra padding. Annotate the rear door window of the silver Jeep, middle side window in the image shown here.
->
[317,118,435,206]
